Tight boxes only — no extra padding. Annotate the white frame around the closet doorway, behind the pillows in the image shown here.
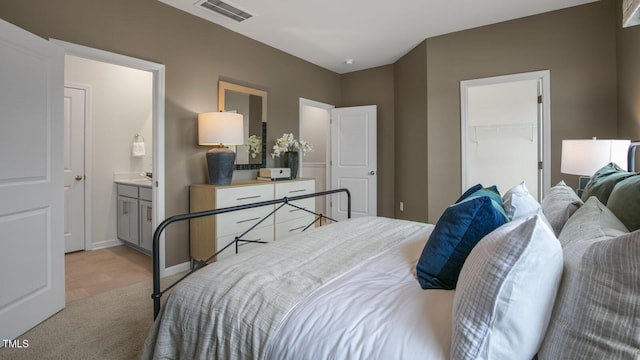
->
[460,70,551,200]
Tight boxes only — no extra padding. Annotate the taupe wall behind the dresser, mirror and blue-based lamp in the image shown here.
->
[0,0,341,265]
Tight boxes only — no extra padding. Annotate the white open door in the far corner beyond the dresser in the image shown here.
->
[330,105,378,220]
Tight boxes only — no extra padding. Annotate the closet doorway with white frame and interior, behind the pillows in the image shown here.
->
[460,70,551,200]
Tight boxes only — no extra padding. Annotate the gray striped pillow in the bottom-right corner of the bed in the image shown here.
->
[538,230,640,360]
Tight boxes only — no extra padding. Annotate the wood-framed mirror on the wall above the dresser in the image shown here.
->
[218,80,267,170]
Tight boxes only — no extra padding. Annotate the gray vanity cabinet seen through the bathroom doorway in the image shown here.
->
[116,184,153,253]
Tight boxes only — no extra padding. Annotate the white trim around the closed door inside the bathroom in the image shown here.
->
[64,81,92,250]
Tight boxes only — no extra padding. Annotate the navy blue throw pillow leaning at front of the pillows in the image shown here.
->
[416,196,507,290]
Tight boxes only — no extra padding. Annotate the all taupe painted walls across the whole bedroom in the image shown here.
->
[0,0,640,265]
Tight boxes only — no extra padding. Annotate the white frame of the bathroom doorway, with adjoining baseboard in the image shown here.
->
[50,39,174,277]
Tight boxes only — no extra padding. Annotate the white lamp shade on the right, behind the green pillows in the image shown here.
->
[560,139,631,176]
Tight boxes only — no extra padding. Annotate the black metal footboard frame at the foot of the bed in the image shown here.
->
[151,189,351,320]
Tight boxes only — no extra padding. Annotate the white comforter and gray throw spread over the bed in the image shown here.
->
[143,218,453,359]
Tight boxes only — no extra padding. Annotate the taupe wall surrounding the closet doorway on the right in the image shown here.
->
[396,0,617,222]
